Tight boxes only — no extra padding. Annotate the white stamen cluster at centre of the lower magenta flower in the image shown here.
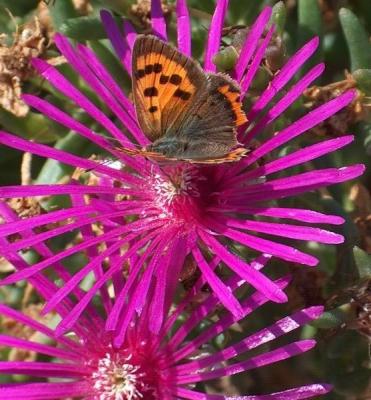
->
[92,353,146,400]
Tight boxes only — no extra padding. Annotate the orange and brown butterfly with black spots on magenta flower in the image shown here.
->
[122,35,247,164]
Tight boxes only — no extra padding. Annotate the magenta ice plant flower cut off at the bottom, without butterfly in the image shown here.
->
[0,250,330,400]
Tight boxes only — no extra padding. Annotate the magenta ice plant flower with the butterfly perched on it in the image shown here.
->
[0,0,364,324]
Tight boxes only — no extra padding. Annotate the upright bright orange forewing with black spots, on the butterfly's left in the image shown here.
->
[132,35,206,141]
